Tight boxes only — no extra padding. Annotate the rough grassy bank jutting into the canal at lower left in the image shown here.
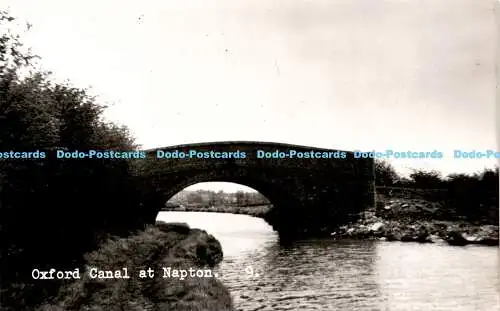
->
[33,223,233,311]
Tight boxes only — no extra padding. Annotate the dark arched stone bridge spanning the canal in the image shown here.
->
[137,141,375,236]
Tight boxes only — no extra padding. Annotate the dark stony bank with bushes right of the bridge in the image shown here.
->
[370,165,499,246]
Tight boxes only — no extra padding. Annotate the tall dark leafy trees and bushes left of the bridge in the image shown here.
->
[0,11,158,310]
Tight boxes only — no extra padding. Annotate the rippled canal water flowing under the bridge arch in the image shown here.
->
[158,212,499,311]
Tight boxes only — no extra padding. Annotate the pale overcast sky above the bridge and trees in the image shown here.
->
[0,0,498,193]
